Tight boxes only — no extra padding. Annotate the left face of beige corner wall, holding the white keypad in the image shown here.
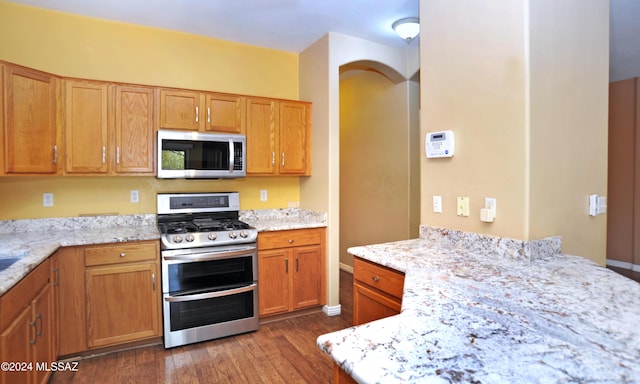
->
[420,0,528,239]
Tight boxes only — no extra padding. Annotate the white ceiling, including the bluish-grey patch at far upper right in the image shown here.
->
[10,0,640,81]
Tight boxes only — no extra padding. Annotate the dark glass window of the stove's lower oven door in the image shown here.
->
[169,291,254,332]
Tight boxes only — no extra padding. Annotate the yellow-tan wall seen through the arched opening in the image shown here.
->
[340,70,420,266]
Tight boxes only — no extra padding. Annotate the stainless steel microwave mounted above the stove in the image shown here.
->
[157,130,247,179]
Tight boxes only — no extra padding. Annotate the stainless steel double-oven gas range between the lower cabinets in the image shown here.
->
[157,192,258,348]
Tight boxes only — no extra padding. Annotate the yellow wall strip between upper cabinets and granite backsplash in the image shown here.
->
[0,177,299,220]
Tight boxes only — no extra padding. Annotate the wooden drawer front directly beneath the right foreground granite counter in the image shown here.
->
[353,257,404,298]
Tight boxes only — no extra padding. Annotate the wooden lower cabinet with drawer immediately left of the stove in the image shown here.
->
[54,241,162,356]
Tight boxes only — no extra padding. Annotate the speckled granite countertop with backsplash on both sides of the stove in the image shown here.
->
[0,208,327,296]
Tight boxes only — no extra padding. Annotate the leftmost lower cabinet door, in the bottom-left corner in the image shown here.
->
[0,307,29,384]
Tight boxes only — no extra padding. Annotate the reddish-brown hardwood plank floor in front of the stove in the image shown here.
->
[49,271,353,384]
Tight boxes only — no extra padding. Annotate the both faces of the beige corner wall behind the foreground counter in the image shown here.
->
[420,0,609,264]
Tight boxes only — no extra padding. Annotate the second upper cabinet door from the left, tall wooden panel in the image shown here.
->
[64,80,109,173]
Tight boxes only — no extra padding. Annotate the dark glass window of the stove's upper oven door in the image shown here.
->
[168,255,255,295]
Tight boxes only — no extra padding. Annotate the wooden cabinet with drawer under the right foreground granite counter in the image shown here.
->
[353,257,404,325]
